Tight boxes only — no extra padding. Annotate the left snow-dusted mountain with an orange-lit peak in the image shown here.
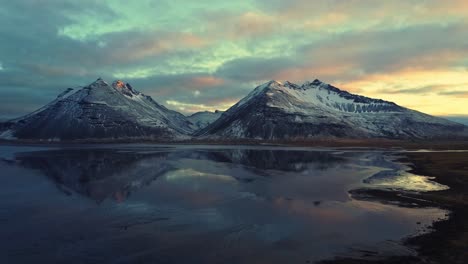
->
[0,78,193,140]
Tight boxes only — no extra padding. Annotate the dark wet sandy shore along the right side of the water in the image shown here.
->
[322,152,468,264]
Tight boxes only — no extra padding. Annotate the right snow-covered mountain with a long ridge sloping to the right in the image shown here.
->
[195,80,468,140]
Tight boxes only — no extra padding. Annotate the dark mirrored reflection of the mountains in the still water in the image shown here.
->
[11,149,346,202]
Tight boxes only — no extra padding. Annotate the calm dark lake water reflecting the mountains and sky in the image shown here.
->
[0,145,446,263]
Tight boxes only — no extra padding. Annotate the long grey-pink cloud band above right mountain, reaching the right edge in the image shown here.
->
[217,22,468,82]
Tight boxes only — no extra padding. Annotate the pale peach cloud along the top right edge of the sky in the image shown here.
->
[256,0,468,32]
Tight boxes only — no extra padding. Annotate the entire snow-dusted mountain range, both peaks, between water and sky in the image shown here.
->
[0,78,468,141]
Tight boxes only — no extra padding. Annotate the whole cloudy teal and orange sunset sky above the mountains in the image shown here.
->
[0,0,468,121]
